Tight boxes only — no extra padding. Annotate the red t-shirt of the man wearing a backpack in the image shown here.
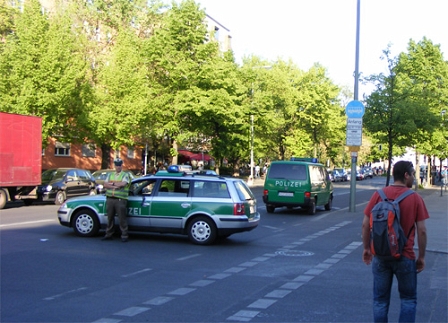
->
[364,185,429,259]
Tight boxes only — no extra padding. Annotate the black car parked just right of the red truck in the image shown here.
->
[37,168,96,205]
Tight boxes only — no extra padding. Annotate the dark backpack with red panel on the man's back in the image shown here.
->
[370,190,414,260]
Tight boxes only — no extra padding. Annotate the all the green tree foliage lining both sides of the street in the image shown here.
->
[0,0,448,173]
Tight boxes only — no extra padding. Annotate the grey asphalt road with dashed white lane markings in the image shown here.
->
[0,178,447,323]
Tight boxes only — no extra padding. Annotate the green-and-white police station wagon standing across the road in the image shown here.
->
[57,166,260,245]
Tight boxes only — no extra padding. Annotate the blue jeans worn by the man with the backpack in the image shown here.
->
[372,257,417,322]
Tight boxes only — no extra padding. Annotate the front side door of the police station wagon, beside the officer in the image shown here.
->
[127,179,156,231]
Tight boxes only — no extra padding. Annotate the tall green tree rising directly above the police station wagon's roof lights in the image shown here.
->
[145,0,218,163]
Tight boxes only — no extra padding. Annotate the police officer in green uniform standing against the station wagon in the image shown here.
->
[103,158,131,242]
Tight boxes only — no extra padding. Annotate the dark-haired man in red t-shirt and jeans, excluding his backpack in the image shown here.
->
[362,161,429,322]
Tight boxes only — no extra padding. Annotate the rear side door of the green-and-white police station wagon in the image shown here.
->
[150,178,191,230]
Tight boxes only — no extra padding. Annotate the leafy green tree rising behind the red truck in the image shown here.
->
[0,0,91,145]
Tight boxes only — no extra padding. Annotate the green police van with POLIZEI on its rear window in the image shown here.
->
[263,157,333,214]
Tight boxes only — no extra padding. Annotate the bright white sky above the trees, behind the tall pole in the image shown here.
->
[196,0,448,98]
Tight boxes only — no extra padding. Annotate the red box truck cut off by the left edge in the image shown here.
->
[0,112,42,209]
